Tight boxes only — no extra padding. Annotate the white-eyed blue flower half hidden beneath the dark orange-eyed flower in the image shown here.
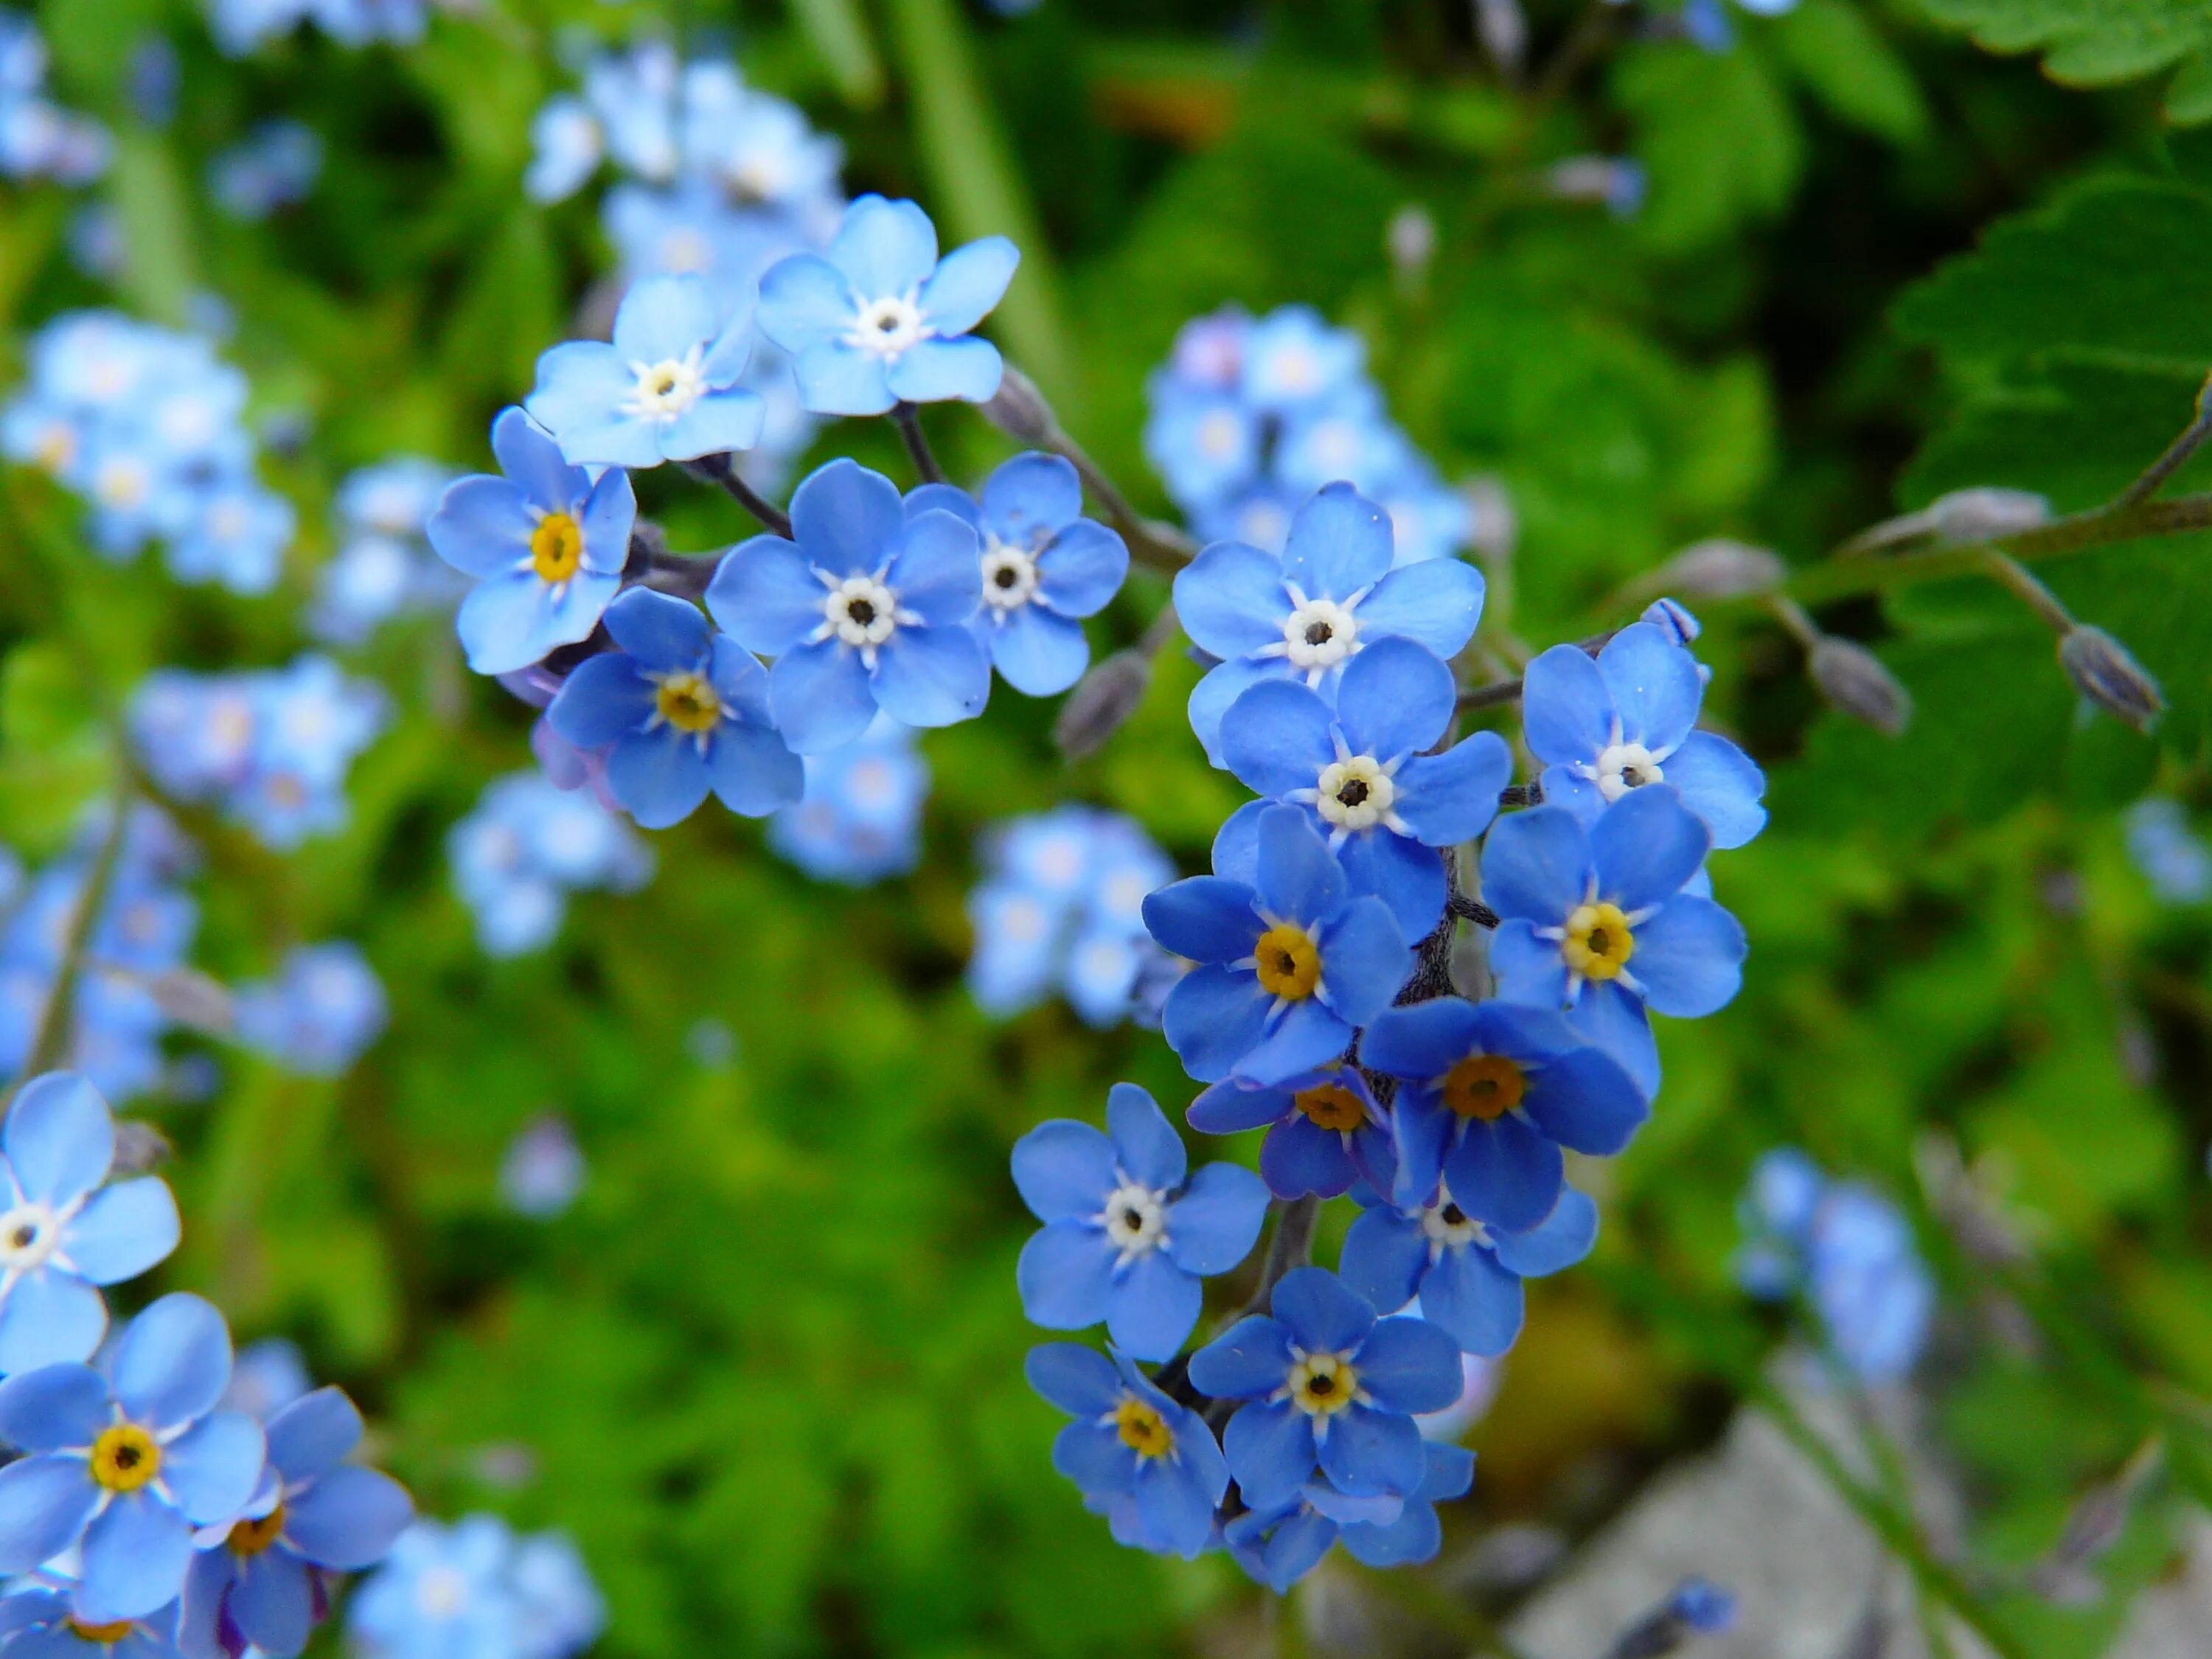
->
[1338,1183,1597,1358]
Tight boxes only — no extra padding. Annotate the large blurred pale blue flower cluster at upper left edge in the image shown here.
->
[0,312,294,593]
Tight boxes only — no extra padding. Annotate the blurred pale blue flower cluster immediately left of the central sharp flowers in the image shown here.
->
[969,807,1175,1026]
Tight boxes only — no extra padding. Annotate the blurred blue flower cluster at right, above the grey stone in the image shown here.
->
[1736,1148,1935,1385]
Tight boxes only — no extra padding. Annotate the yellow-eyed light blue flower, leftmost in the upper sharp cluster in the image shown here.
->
[425,409,637,675]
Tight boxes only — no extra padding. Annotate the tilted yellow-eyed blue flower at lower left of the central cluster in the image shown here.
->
[1022,1343,1230,1562]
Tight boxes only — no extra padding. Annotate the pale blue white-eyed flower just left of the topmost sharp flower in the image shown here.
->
[522,276,768,467]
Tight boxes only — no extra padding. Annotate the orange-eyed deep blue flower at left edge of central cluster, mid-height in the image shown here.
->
[1144,807,1413,1084]
